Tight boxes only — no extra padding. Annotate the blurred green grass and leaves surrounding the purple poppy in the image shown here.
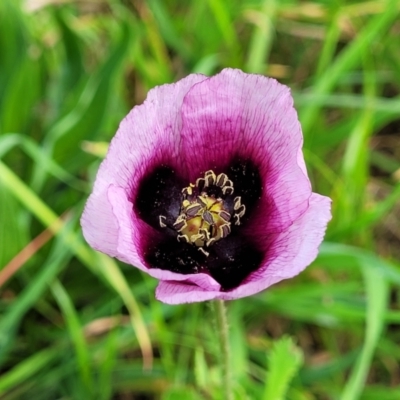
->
[0,0,400,400]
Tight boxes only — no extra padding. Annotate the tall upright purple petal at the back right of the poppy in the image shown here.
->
[181,69,311,233]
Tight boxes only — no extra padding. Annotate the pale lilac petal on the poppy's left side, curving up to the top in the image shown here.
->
[81,74,207,259]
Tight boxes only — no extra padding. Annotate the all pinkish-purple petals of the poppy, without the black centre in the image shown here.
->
[81,69,330,304]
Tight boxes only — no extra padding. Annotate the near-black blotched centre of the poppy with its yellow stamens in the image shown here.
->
[134,159,264,290]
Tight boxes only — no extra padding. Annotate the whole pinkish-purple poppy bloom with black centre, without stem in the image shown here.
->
[81,69,331,304]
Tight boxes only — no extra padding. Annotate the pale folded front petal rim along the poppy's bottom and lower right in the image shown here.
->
[156,193,331,304]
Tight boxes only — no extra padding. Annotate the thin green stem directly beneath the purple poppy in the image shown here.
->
[213,300,233,400]
